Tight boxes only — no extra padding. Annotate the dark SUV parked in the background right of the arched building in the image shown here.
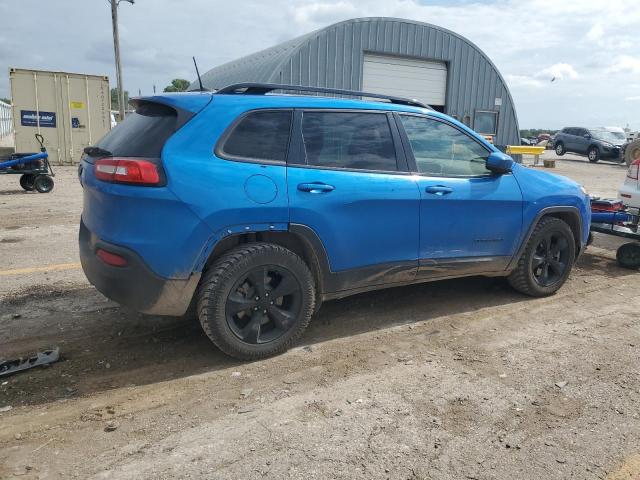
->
[554,127,625,163]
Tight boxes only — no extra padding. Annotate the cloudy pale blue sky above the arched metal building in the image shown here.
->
[0,0,640,129]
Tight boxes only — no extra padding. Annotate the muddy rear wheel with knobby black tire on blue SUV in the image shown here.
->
[197,243,316,360]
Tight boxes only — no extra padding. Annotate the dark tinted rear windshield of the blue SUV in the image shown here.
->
[96,102,178,158]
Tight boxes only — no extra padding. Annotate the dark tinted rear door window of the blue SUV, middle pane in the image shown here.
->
[302,111,398,171]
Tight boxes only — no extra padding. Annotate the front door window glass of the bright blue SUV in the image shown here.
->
[400,115,490,176]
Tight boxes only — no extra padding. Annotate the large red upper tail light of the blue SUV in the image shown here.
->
[94,157,160,185]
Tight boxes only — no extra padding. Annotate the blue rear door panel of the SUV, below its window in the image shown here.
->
[288,165,420,272]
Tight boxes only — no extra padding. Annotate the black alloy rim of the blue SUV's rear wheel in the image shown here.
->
[225,265,302,345]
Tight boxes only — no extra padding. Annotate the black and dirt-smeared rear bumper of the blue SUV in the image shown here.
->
[79,221,200,316]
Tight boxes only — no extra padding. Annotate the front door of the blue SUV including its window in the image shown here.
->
[397,114,522,277]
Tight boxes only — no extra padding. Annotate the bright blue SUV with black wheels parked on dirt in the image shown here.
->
[79,84,591,359]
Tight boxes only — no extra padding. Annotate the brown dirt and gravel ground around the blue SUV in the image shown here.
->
[0,153,640,480]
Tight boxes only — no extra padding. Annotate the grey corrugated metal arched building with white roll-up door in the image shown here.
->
[199,17,520,145]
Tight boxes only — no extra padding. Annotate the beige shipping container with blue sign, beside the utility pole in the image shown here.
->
[9,68,111,165]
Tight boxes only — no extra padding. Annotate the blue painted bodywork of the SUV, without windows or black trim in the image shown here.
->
[82,93,590,298]
